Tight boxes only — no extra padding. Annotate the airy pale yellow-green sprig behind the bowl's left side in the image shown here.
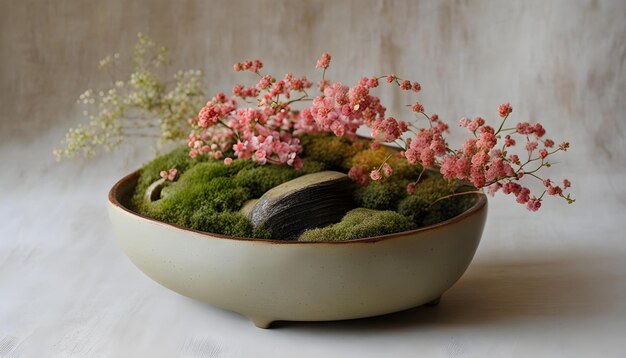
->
[54,33,205,160]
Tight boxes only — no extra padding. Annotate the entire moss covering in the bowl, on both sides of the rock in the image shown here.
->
[131,136,476,241]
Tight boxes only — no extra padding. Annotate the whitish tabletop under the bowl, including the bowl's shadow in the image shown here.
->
[0,144,626,357]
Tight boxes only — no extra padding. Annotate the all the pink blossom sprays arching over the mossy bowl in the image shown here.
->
[183,53,574,211]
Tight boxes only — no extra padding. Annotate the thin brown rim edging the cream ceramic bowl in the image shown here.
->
[109,170,487,245]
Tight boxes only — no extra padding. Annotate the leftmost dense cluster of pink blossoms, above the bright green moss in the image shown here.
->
[188,60,312,168]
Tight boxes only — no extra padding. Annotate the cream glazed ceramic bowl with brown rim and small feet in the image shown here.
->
[108,171,487,328]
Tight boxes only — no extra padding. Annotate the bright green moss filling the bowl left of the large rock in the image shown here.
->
[133,157,323,238]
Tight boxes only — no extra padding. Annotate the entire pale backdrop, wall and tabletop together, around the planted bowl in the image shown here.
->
[0,0,626,357]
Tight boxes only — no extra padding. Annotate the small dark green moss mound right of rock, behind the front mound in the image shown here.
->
[354,176,408,210]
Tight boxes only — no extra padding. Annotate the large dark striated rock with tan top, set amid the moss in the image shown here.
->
[247,171,355,240]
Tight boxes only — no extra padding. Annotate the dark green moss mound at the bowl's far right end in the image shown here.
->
[398,173,476,226]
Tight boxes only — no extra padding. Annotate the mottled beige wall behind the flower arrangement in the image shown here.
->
[0,0,626,172]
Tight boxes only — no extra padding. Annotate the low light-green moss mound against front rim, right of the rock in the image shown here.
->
[298,208,415,241]
